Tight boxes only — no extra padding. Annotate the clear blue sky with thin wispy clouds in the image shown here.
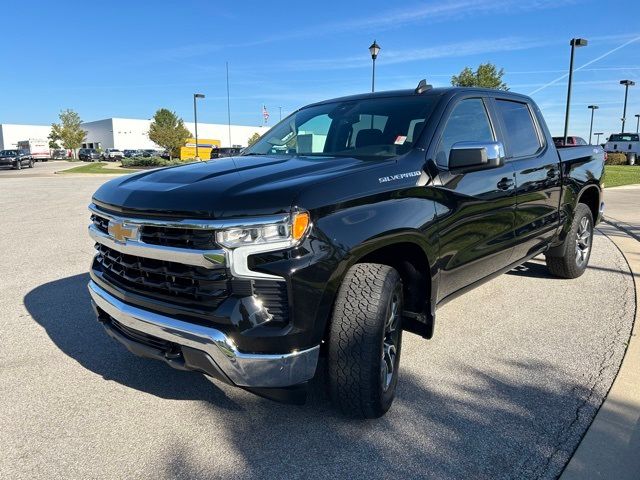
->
[0,0,640,137]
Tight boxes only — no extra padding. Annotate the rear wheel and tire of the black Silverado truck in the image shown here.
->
[546,203,593,278]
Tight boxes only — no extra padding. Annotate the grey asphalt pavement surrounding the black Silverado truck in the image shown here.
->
[0,174,635,479]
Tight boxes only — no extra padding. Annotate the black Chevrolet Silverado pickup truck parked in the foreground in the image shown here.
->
[89,81,604,417]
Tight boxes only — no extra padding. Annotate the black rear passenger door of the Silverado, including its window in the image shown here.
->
[493,97,561,262]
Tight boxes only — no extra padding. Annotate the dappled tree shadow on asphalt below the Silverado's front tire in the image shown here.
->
[162,363,600,479]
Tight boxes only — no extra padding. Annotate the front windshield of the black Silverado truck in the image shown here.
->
[242,95,438,158]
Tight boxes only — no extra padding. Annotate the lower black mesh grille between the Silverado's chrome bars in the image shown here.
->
[96,243,230,311]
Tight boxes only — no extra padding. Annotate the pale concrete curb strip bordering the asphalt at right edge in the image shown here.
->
[560,223,640,480]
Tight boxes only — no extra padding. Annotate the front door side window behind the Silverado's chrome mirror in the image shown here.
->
[436,98,495,167]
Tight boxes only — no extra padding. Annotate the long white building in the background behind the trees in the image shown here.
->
[0,118,270,150]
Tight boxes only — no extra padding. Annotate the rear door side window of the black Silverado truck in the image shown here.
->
[496,99,541,158]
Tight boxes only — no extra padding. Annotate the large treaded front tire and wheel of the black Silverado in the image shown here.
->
[328,263,403,418]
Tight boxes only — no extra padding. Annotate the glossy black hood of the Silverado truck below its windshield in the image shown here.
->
[93,156,380,218]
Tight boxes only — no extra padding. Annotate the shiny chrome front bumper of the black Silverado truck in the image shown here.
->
[89,281,320,388]
